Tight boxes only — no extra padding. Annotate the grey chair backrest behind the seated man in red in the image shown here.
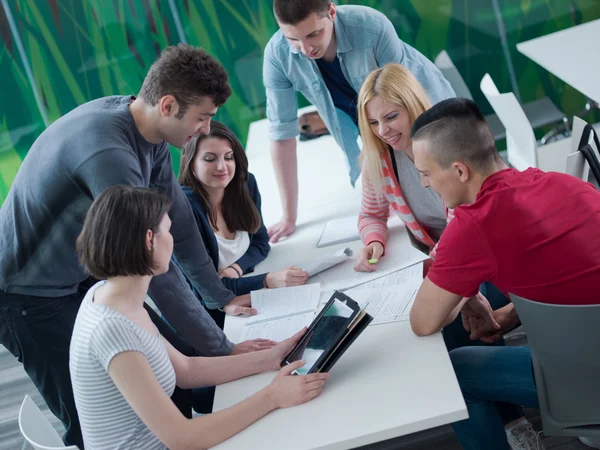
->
[510,294,600,437]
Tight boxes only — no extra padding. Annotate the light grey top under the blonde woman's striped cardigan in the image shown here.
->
[394,150,446,241]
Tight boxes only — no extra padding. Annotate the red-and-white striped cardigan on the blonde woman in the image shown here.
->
[358,152,453,258]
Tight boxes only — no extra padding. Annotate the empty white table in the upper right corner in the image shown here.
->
[517,19,600,103]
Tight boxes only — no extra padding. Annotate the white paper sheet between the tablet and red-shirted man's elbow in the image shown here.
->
[346,279,421,325]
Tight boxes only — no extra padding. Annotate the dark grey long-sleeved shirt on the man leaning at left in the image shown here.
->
[0,96,234,355]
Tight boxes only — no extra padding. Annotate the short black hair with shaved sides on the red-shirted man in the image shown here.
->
[410,98,500,170]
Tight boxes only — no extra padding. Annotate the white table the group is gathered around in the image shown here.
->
[213,121,467,450]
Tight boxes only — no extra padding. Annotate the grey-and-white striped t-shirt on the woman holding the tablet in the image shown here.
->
[70,281,175,450]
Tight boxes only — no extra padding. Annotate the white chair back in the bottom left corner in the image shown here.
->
[19,395,79,450]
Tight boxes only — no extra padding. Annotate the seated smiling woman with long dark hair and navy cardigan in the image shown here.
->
[179,120,308,309]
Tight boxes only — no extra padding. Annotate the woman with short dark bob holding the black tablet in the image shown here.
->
[69,186,327,450]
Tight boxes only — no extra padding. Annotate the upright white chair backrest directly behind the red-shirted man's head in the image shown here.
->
[479,73,538,170]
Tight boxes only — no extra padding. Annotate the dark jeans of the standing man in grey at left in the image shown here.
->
[0,280,191,449]
